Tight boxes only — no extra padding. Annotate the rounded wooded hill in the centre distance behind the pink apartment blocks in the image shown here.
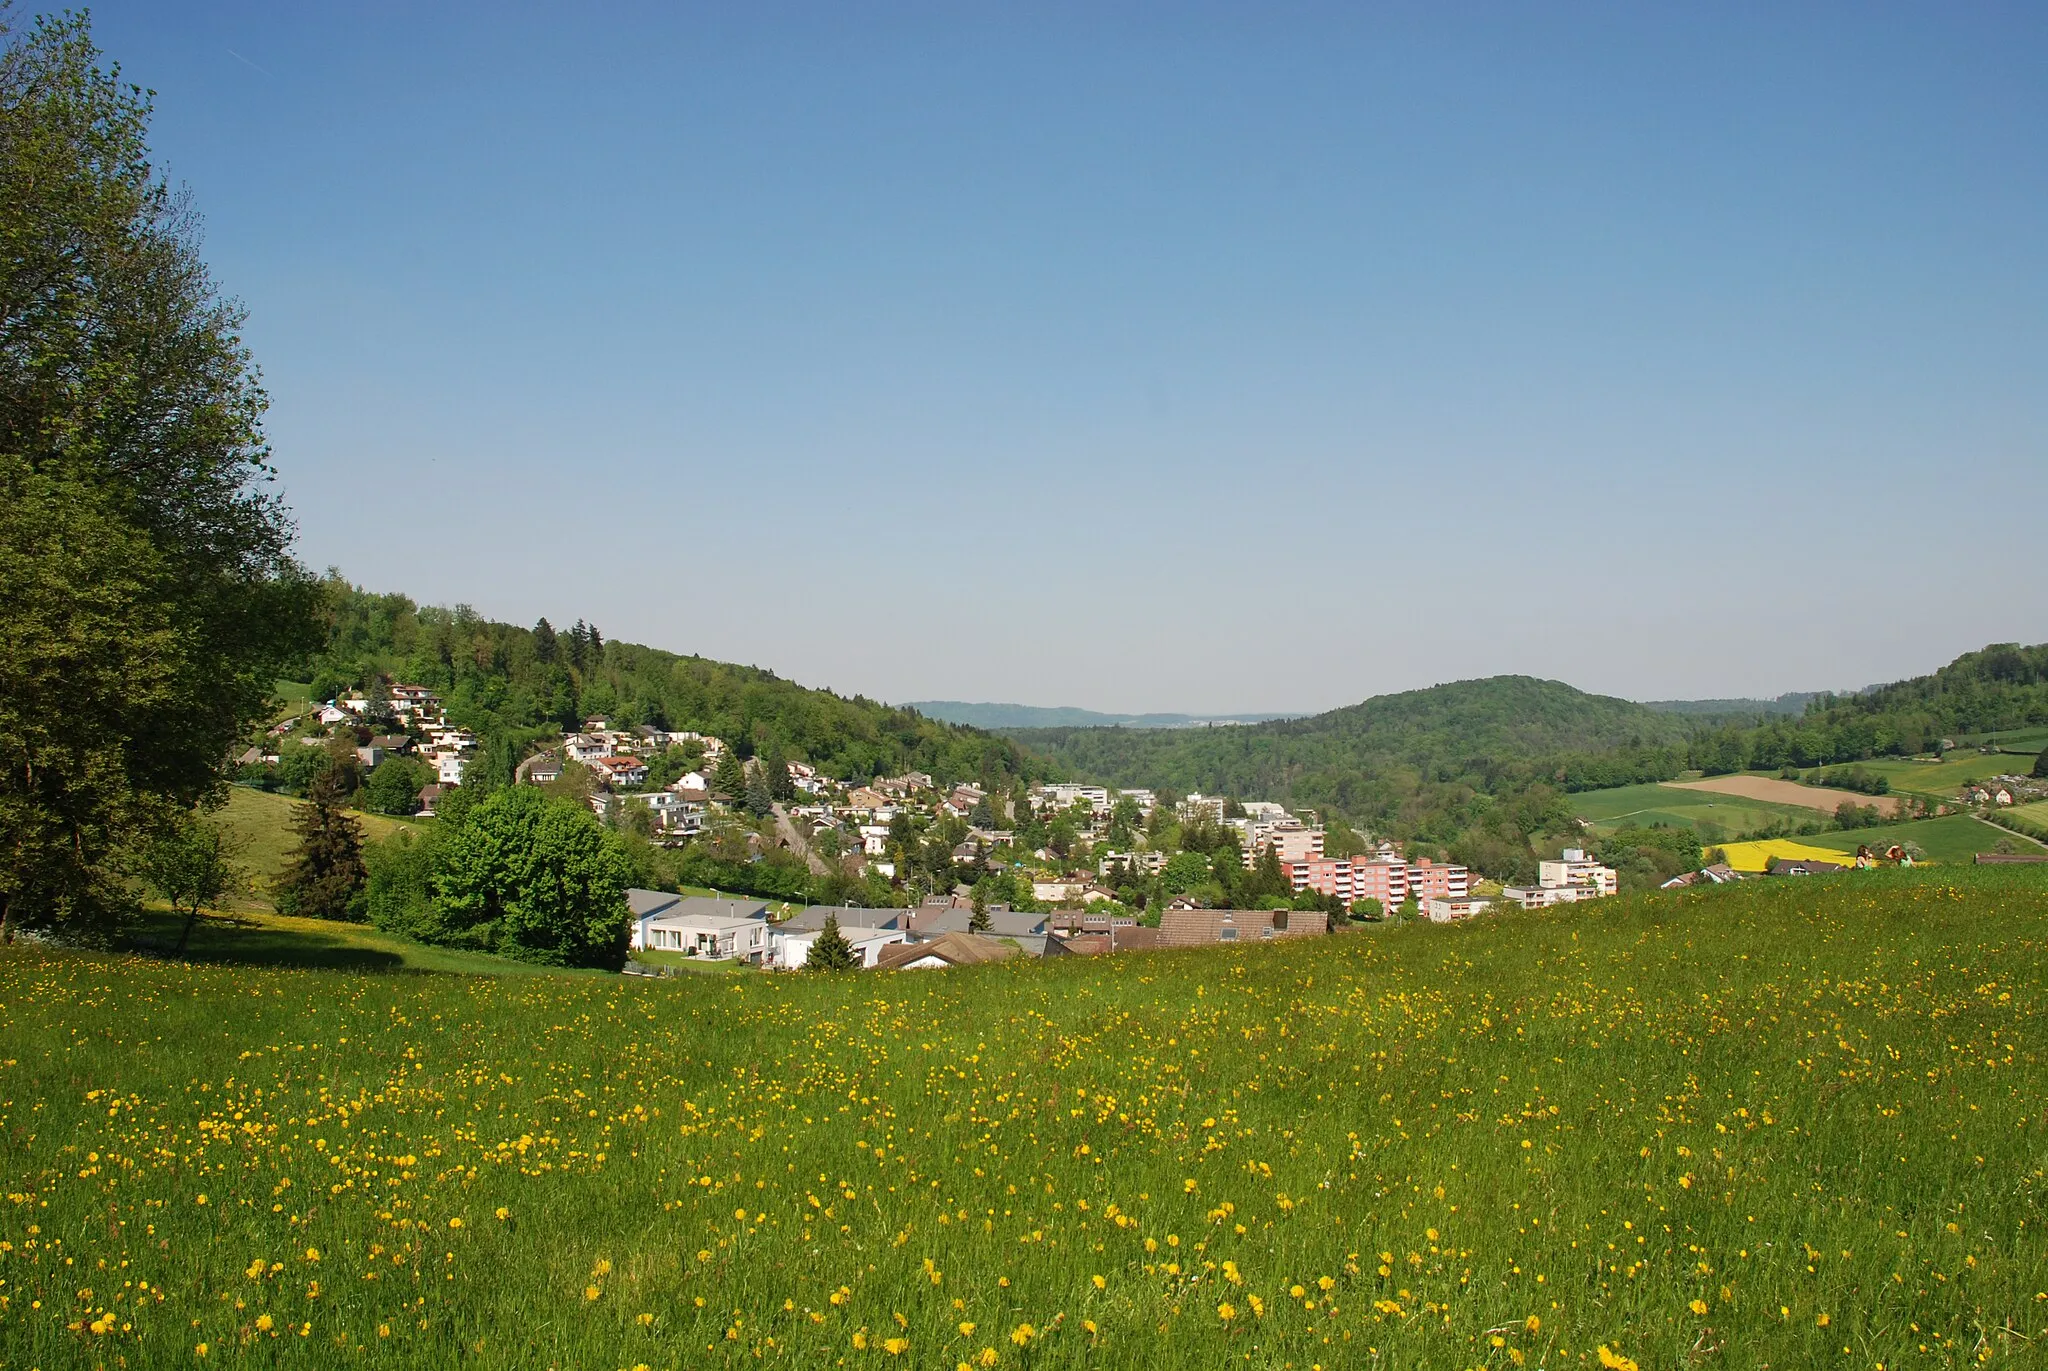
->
[1004,676,1692,814]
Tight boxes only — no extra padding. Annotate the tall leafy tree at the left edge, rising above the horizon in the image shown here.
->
[0,12,315,937]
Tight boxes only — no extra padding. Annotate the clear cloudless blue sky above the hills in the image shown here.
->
[83,0,2048,711]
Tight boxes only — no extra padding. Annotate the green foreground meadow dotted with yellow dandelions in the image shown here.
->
[0,867,2048,1371]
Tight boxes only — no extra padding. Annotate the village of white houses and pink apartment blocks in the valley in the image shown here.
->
[240,682,1662,975]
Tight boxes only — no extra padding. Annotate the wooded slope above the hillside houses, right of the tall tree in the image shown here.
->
[303,574,1044,789]
